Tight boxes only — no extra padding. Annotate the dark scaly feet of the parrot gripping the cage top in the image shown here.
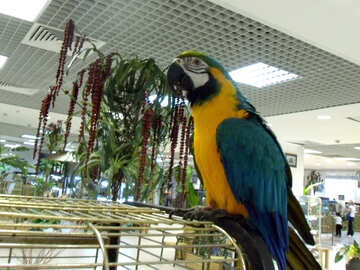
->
[169,206,243,222]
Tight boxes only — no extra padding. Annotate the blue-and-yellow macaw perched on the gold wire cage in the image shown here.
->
[167,51,320,270]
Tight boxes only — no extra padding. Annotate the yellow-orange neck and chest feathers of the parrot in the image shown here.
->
[192,69,248,217]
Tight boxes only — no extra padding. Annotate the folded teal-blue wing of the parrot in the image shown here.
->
[216,118,288,269]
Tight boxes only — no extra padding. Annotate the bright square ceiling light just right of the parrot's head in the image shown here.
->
[230,62,298,88]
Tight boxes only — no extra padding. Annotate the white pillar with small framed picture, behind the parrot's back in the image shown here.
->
[279,141,304,198]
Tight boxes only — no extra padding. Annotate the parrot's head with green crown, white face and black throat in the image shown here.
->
[167,51,231,105]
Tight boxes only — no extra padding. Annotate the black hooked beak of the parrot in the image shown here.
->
[167,62,194,92]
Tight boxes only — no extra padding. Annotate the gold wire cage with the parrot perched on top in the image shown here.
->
[0,195,245,270]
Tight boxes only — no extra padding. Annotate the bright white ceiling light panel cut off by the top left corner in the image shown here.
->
[0,0,48,22]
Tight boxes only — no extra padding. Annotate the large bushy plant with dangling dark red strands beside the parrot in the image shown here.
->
[34,20,197,205]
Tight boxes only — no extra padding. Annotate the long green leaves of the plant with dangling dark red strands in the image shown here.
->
[71,52,171,199]
